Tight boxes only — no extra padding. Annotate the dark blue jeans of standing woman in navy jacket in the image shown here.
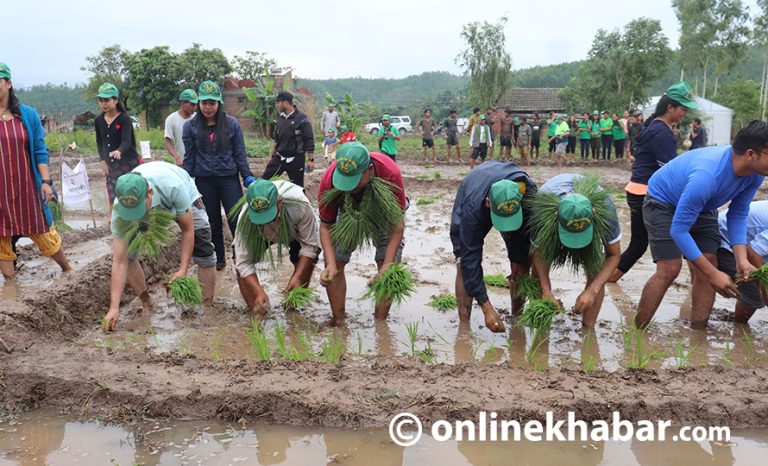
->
[195,175,243,264]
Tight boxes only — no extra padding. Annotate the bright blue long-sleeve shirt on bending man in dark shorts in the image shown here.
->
[648,146,765,261]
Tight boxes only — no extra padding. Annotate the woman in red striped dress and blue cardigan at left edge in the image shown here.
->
[0,63,72,279]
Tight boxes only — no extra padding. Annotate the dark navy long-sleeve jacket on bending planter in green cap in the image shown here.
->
[450,161,536,305]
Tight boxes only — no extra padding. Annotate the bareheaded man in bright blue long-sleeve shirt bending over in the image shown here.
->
[635,120,768,328]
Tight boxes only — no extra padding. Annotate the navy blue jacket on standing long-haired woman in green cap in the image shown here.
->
[181,116,253,180]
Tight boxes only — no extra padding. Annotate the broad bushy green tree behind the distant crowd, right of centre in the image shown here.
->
[558,18,672,111]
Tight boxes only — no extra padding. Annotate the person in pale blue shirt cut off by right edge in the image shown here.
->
[717,201,768,324]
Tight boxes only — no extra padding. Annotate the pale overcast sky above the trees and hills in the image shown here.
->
[0,0,754,87]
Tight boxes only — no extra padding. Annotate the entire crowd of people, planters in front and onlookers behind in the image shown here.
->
[0,63,768,338]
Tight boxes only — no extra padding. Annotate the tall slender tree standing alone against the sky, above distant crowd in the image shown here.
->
[456,16,512,107]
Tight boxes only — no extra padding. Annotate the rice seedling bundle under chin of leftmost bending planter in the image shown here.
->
[115,209,176,259]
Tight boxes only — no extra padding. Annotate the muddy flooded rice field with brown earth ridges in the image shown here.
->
[0,155,768,466]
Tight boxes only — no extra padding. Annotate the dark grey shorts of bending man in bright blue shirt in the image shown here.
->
[643,195,720,262]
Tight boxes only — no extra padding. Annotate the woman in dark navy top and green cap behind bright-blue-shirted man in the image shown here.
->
[609,81,699,282]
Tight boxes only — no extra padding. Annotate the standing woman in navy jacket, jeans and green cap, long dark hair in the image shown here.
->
[182,81,255,270]
